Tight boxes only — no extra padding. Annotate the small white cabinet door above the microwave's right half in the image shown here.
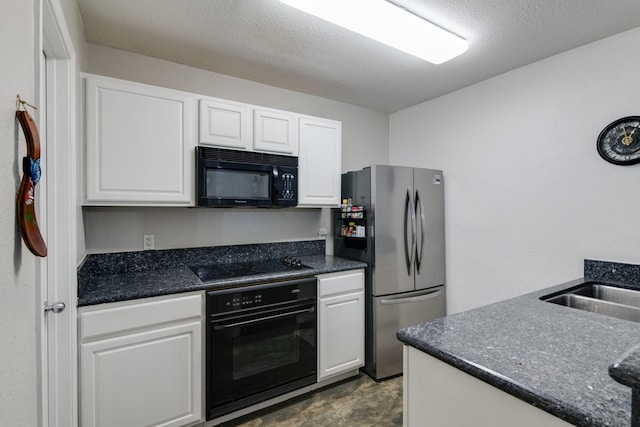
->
[253,108,298,156]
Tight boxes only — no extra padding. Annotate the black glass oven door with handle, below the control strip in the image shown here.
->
[207,299,317,419]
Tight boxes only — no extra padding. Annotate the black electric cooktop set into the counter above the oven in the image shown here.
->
[189,257,311,282]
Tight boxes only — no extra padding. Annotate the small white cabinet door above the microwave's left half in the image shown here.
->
[200,98,253,150]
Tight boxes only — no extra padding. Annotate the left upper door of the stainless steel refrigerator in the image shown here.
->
[370,165,416,296]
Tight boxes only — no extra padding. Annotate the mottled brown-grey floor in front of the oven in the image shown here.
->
[221,373,402,427]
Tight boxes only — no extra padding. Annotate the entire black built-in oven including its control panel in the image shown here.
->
[206,278,317,420]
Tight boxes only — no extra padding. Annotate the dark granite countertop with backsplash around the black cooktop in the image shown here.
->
[78,240,367,307]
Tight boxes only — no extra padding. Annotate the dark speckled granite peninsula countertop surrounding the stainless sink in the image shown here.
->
[398,260,640,426]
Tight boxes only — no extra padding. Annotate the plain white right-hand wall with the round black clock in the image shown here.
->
[390,29,640,312]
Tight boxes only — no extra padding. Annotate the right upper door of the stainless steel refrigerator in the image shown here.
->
[413,169,445,290]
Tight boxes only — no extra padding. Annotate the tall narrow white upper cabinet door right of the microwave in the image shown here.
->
[298,117,342,207]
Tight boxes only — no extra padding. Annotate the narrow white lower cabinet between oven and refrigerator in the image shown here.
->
[317,270,364,381]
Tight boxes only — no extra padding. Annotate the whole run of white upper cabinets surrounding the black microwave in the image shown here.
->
[83,74,342,207]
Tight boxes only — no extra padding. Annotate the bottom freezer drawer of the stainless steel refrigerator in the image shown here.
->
[365,286,446,380]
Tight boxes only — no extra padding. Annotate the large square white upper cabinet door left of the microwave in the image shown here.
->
[85,76,195,205]
